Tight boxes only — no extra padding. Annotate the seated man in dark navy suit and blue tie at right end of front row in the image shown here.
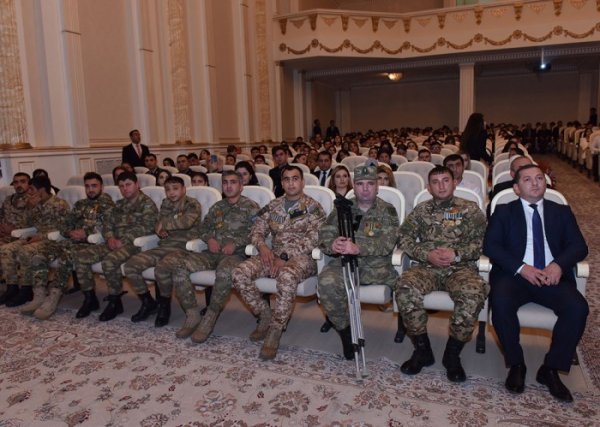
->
[483,164,589,402]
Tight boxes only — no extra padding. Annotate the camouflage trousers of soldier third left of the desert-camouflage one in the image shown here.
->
[72,244,140,295]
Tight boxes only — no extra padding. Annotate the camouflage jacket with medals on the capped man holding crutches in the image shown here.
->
[319,198,399,285]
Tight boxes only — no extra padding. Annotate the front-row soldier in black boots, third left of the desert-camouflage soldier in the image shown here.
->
[73,172,158,322]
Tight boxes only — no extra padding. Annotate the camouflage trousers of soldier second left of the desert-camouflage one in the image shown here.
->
[123,247,187,297]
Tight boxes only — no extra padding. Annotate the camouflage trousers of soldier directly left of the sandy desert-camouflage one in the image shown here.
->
[154,251,245,312]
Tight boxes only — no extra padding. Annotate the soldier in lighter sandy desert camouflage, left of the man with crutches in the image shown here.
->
[231,166,325,360]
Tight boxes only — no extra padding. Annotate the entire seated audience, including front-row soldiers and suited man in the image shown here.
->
[0,120,588,401]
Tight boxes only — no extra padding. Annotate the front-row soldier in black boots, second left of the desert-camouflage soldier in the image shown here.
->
[123,176,202,327]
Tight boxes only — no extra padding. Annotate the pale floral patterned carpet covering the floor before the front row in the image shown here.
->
[0,153,600,427]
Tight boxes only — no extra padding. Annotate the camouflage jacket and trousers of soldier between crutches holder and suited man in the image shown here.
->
[396,197,489,342]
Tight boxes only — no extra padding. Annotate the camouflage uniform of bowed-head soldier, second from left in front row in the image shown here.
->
[0,196,69,287]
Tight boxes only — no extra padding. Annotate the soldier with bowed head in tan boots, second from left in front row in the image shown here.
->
[0,176,69,314]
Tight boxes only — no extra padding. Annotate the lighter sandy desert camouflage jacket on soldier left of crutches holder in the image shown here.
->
[250,194,325,258]
